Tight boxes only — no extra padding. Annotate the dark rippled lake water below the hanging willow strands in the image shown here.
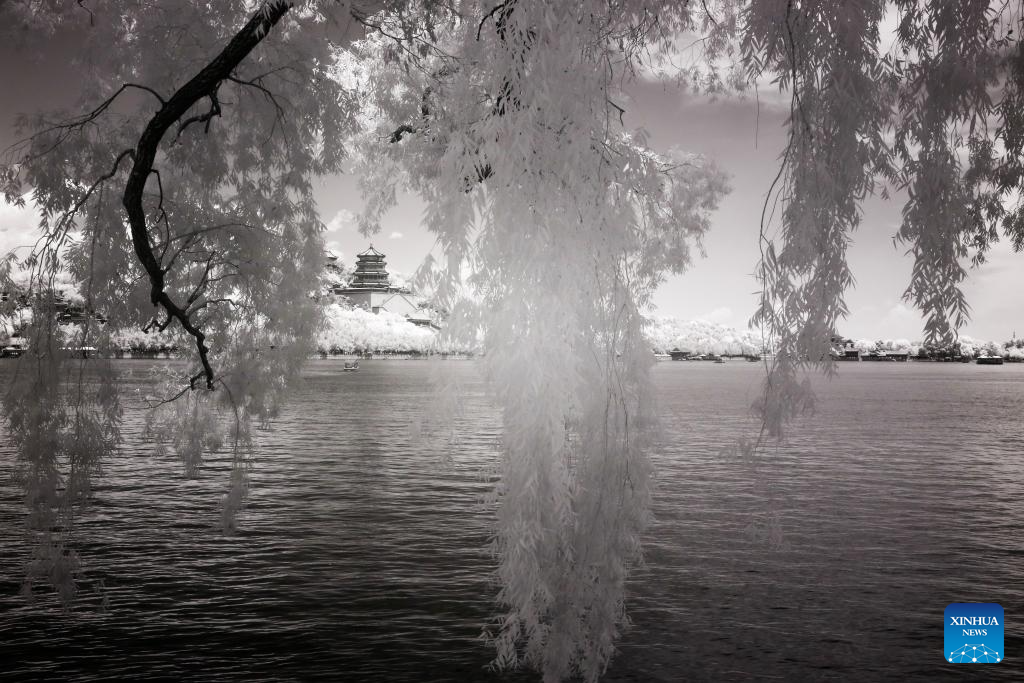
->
[0,360,1024,682]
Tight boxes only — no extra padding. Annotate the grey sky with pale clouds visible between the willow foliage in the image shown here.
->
[0,14,1024,348]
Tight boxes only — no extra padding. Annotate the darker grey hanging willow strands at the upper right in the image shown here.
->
[739,0,1024,434]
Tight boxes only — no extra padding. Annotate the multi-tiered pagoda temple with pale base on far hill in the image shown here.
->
[327,245,436,327]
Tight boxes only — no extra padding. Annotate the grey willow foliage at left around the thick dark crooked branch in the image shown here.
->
[0,0,353,610]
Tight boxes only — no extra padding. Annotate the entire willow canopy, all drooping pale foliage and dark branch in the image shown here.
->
[3,0,1024,680]
